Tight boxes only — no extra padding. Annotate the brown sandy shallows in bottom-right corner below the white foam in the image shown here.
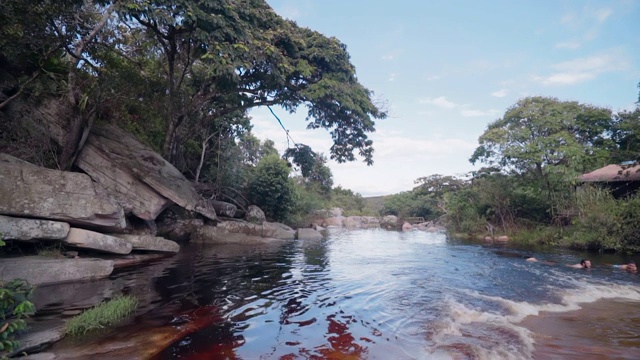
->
[521,299,640,359]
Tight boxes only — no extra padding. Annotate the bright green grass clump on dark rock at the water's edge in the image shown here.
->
[64,295,138,336]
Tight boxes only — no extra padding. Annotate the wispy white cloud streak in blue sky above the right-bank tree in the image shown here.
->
[533,51,628,85]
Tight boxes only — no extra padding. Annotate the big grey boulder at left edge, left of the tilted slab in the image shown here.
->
[0,162,126,231]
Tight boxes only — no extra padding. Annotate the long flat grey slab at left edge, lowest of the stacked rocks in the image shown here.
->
[0,256,113,285]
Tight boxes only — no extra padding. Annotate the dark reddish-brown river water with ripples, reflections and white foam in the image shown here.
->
[36,229,640,360]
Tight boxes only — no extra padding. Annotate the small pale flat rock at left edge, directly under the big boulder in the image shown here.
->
[0,215,69,240]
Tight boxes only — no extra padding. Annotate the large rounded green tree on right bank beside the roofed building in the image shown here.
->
[470,97,611,190]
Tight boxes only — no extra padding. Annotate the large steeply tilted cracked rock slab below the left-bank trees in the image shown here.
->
[76,125,216,220]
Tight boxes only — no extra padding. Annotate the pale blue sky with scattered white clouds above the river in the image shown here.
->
[250,0,640,197]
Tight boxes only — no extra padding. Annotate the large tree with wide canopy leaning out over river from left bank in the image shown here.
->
[115,0,386,164]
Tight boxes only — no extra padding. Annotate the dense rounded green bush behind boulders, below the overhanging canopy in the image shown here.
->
[248,155,295,221]
